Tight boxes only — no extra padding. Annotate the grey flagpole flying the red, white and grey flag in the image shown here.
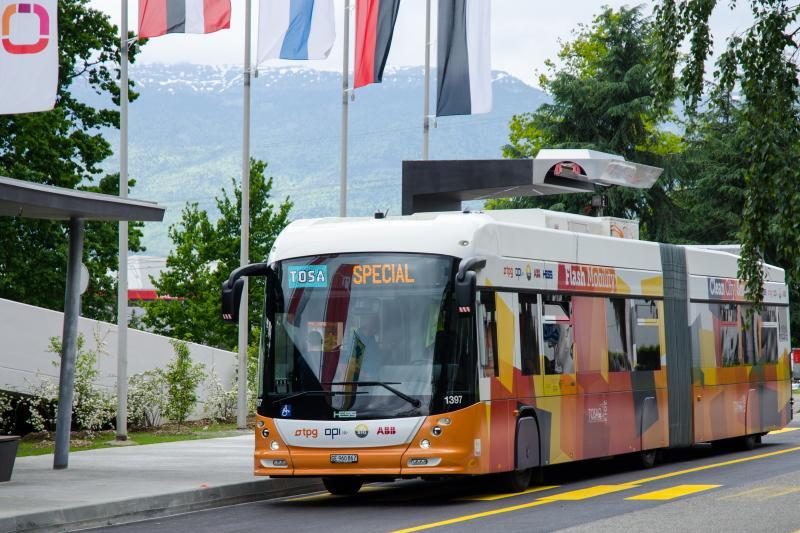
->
[116,0,128,441]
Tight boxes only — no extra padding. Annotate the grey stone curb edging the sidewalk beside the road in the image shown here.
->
[0,478,322,533]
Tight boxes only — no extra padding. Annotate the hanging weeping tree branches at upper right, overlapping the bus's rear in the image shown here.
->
[654,0,800,305]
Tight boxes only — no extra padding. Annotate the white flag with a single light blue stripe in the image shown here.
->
[257,0,336,64]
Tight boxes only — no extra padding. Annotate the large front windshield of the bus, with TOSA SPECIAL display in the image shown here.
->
[258,253,477,420]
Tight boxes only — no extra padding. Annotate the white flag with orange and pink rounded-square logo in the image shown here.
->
[0,0,58,115]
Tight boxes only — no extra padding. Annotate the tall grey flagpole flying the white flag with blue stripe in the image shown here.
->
[236,0,252,429]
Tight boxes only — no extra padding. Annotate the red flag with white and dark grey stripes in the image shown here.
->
[139,0,231,39]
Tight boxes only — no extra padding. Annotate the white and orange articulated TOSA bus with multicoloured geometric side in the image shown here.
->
[223,206,792,494]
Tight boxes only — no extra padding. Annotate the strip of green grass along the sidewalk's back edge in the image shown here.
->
[17,421,250,457]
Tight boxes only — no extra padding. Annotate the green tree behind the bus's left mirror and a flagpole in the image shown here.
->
[143,159,292,349]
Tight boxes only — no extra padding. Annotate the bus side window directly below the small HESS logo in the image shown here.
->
[542,294,575,374]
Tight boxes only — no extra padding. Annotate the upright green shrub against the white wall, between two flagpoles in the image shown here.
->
[164,340,206,425]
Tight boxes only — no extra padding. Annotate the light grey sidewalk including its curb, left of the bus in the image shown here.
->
[0,434,321,533]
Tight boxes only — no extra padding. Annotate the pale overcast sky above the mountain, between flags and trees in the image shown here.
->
[90,0,750,85]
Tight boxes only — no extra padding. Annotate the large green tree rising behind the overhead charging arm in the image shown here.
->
[489,7,683,241]
